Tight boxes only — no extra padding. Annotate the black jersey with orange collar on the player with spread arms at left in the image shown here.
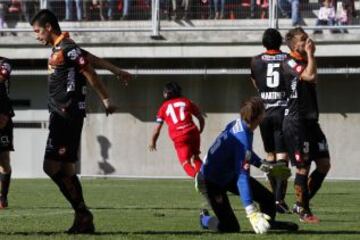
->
[48,33,88,117]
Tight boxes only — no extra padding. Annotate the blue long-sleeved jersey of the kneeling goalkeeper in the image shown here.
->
[201,119,261,207]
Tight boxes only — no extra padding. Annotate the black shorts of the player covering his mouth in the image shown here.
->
[283,117,330,167]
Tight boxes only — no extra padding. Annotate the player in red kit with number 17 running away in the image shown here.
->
[149,82,205,178]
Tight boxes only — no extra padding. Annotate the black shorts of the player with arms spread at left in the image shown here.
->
[45,113,84,162]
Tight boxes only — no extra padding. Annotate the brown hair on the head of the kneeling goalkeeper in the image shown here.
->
[240,97,265,124]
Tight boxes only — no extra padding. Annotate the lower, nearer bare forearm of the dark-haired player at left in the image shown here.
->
[82,64,116,115]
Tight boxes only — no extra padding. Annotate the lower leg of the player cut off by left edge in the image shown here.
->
[0,151,11,209]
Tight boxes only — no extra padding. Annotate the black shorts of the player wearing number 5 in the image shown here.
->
[260,111,286,153]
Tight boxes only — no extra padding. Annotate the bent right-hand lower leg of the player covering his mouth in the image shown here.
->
[308,158,331,199]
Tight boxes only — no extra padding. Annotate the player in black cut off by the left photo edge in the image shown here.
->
[0,57,14,209]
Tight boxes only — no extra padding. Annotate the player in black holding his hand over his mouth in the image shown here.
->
[283,28,330,223]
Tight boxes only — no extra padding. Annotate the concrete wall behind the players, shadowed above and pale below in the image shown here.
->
[8,75,360,179]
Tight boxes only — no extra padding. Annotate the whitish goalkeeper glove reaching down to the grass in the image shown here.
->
[245,203,270,234]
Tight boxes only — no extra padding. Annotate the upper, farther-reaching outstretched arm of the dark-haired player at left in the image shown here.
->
[87,52,132,86]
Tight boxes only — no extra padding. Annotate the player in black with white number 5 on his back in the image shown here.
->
[251,28,290,213]
